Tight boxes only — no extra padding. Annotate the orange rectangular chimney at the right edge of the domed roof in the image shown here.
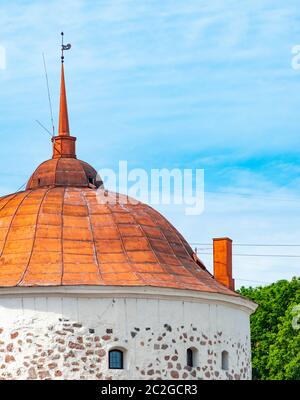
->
[213,238,234,290]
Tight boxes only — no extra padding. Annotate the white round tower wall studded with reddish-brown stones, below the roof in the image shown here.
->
[0,289,253,379]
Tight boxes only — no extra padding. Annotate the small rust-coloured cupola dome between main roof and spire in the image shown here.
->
[26,158,102,189]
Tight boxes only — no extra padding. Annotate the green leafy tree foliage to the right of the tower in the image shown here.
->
[239,278,300,380]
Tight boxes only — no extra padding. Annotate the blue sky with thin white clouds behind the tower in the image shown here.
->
[0,0,300,285]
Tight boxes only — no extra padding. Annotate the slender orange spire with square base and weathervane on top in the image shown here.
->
[52,32,76,158]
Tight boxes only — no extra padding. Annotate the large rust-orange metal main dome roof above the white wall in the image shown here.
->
[0,187,234,295]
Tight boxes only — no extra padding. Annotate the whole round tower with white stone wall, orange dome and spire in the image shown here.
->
[0,42,256,379]
